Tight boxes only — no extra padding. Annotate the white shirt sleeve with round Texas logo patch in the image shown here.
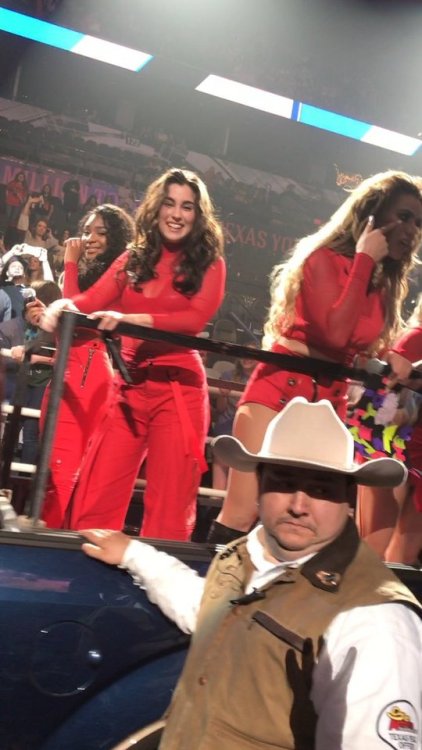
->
[311,603,422,750]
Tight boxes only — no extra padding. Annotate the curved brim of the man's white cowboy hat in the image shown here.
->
[211,435,407,487]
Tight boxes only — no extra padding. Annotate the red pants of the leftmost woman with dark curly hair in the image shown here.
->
[41,334,113,529]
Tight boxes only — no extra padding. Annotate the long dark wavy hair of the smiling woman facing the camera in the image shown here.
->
[125,169,224,296]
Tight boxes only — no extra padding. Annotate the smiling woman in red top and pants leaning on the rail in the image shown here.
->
[44,169,225,540]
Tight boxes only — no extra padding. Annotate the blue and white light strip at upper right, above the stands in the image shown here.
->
[196,75,422,156]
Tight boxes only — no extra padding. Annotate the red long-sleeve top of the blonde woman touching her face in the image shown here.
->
[274,247,384,364]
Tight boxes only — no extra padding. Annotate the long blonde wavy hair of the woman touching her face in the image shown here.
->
[263,170,422,348]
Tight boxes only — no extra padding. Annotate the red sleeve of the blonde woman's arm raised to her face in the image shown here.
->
[300,247,374,349]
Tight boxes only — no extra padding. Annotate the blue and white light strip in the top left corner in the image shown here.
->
[0,8,152,72]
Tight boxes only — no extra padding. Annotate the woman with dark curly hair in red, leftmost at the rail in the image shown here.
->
[41,204,135,529]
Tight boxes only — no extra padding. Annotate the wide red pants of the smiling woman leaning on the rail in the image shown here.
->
[71,365,209,541]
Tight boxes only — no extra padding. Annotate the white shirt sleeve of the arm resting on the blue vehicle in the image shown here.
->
[119,540,205,634]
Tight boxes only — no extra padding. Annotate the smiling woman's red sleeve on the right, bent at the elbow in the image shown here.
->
[152,258,226,334]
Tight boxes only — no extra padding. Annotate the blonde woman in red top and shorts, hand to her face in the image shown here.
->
[208,171,422,543]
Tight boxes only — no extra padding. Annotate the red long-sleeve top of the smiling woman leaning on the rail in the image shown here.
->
[68,247,226,371]
